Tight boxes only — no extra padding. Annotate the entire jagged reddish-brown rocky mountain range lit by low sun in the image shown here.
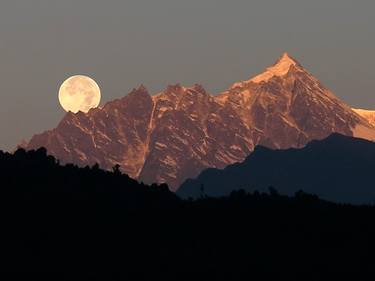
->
[24,54,375,190]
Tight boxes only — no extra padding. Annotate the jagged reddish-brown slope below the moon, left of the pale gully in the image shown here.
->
[26,87,153,178]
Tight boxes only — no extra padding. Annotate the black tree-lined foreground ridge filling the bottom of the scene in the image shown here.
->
[0,149,375,280]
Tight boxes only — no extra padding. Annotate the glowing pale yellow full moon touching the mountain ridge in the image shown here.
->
[59,75,101,113]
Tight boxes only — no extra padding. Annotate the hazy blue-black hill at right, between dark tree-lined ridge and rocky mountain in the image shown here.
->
[178,134,375,204]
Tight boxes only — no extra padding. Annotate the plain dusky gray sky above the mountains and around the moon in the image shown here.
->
[0,0,375,150]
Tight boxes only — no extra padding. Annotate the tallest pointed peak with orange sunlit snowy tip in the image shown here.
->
[217,53,375,148]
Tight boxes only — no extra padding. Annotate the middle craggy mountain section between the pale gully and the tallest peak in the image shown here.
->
[140,85,252,187]
